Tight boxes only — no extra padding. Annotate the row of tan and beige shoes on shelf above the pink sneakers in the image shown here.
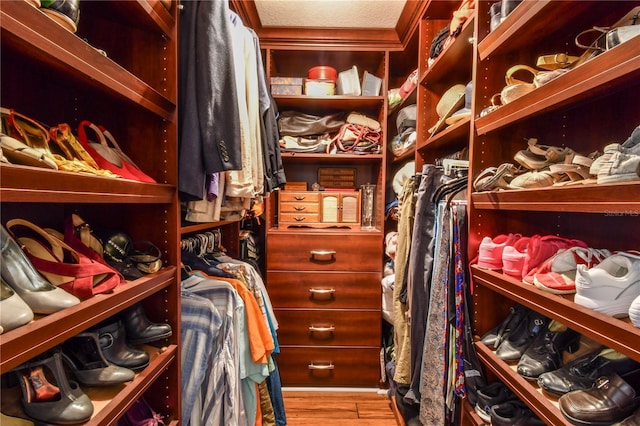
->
[473,126,640,192]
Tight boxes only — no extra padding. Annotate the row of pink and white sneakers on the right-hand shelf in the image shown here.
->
[477,234,640,327]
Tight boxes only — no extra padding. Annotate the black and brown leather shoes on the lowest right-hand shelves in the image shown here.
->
[482,305,640,425]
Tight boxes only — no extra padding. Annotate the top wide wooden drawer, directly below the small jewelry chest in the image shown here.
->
[267,232,383,271]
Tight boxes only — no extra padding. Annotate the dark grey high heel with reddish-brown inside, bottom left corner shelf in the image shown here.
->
[13,353,93,424]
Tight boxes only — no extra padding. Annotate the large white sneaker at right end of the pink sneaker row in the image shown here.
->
[573,251,640,318]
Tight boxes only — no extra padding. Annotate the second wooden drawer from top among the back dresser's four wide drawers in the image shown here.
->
[267,271,382,310]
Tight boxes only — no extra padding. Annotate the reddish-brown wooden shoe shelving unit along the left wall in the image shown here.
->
[0,0,181,426]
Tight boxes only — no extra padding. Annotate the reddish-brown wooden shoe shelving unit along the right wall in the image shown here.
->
[464,0,640,425]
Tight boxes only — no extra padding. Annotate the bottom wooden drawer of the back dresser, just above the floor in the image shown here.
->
[277,346,380,387]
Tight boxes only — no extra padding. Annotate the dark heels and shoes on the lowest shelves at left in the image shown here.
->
[4,303,172,426]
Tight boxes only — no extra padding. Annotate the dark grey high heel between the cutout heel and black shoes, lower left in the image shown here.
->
[60,331,135,386]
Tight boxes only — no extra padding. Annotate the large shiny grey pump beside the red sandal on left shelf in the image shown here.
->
[0,226,80,314]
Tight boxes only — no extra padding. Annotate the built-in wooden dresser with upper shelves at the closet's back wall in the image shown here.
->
[262,43,389,387]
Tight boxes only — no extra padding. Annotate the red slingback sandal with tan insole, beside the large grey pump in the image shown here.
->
[6,219,120,300]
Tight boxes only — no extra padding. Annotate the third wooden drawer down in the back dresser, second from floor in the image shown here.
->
[275,309,381,347]
